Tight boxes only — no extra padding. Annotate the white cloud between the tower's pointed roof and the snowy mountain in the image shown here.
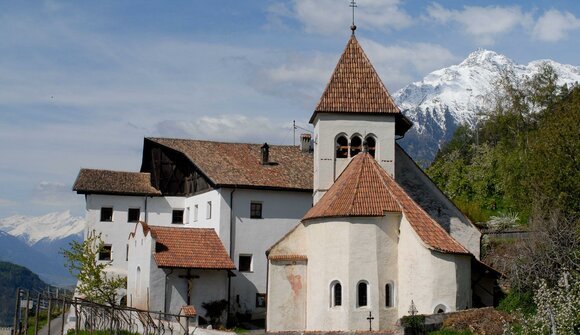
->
[360,39,457,93]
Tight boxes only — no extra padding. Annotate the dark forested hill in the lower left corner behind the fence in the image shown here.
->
[0,262,48,326]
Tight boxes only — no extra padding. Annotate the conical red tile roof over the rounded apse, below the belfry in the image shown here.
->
[302,152,469,254]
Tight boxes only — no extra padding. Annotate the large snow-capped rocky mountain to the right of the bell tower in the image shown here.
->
[393,49,580,162]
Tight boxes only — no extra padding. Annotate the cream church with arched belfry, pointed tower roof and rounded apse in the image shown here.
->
[266,28,493,332]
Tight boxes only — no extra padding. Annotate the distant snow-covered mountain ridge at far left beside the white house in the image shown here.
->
[0,211,85,245]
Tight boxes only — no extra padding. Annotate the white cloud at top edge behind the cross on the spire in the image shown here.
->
[268,0,412,34]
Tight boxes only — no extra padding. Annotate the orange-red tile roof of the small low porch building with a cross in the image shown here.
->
[149,226,236,270]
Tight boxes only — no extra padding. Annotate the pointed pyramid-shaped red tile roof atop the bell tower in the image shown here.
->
[310,35,400,122]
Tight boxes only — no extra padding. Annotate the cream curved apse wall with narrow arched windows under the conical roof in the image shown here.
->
[307,215,399,330]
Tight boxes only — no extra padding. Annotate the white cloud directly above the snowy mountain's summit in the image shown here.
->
[427,3,533,45]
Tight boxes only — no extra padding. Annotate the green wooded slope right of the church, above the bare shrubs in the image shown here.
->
[427,66,580,225]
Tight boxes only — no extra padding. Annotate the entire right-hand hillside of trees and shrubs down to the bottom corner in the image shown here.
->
[427,66,580,334]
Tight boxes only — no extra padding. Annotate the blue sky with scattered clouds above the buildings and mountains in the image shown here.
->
[0,0,580,218]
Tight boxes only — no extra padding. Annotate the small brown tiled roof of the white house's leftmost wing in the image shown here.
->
[73,169,161,195]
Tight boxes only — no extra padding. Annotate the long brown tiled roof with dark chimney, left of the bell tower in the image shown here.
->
[146,138,313,192]
